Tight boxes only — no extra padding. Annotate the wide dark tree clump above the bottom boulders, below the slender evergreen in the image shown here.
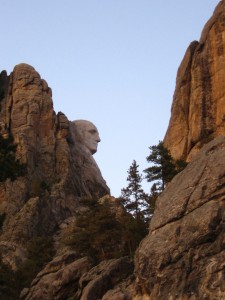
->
[64,199,147,261]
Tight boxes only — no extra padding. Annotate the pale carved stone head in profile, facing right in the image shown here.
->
[73,120,101,154]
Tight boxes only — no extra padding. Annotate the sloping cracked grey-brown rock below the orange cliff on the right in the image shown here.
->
[134,137,225,300]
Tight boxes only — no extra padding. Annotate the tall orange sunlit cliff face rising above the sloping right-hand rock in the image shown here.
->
[164,0,225,161]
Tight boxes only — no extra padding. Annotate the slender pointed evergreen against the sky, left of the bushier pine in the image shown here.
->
[121,160,148,219]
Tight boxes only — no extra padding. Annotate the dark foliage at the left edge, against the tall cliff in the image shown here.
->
[0,135,26,182]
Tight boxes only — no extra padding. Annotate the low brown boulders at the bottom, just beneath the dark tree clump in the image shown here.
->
[21,252,133,300]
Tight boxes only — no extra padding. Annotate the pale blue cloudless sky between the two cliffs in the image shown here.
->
[0,0,219,196]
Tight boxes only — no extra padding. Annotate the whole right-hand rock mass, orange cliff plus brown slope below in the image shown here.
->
[133,0,225,300]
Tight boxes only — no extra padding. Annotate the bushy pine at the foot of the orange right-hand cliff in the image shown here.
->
[144,141,187,191]
